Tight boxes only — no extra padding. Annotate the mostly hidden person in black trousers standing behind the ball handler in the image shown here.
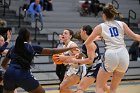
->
[56,35,66,83]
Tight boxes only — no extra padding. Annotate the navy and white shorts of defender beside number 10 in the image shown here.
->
[85,63,101,78]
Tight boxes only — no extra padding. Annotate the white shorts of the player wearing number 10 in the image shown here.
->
[102,47,129,73]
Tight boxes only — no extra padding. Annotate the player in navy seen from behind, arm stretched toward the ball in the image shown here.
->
[2,28,77,93]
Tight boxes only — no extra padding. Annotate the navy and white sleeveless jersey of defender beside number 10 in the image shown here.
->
[82,42,101,70]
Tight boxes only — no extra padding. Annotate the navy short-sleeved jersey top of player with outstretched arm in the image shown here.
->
[6,43,43,69]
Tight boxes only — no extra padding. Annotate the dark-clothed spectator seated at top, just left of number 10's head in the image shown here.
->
[90,0,105,17]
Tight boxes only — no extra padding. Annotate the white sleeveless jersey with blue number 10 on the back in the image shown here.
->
[100,20,125,49]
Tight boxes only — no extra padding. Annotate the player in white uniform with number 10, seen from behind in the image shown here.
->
[85,3,140,93]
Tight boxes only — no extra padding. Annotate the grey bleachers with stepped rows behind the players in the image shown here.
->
[0,0,140,84]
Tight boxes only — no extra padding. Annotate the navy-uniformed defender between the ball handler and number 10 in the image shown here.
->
[59,25,109,93]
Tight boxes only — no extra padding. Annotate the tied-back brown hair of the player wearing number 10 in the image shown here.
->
[103,3,123,19]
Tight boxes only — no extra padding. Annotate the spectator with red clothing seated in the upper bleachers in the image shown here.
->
[81,0,90,15]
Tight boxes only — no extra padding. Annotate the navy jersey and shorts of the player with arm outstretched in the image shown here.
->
[3,43,43,92]
